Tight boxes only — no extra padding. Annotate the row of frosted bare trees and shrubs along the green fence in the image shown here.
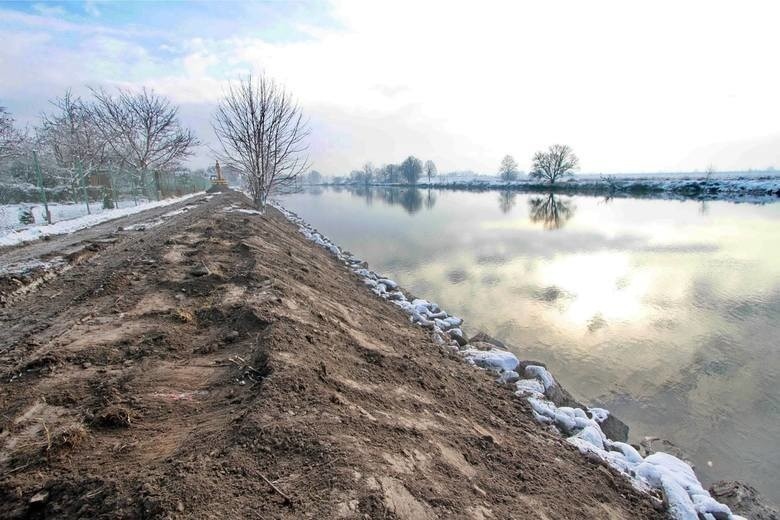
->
[0,88,208,212]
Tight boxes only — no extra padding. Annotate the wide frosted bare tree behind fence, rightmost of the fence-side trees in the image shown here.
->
[92,88,200,198]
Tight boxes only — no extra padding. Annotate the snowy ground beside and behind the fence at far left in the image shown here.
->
[0,192,203,246]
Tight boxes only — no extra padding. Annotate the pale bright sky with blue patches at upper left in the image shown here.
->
[0,0,780,175]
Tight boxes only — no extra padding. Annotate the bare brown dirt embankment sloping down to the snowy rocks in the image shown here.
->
[0,193,663,519]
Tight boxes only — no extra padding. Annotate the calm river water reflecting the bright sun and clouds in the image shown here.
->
[282,188,780,503]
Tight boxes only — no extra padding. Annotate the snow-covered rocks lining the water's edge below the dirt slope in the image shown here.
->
[274,204,742,520]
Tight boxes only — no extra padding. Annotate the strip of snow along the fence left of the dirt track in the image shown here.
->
[0,192,204,246]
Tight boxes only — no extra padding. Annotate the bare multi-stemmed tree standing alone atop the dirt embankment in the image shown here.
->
[212,74,309,211]
